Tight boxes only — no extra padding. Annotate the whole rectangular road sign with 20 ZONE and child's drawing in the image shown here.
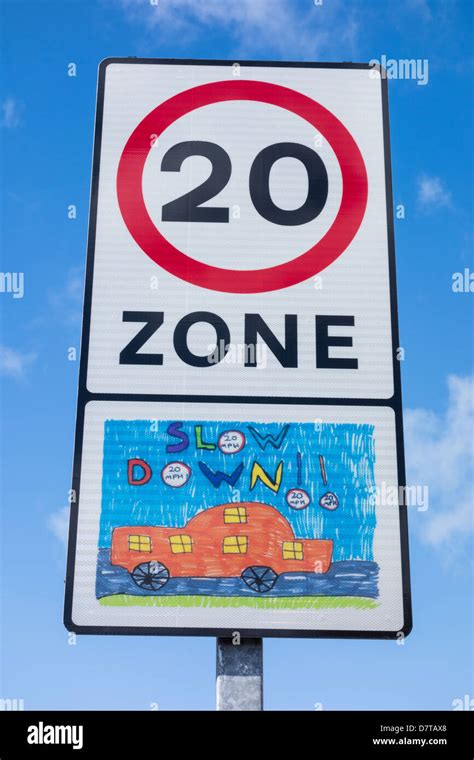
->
[65,59,411,637]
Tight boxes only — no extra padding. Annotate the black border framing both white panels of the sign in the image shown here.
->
[64,57,412,639]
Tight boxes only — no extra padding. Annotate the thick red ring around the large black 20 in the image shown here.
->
[117,80,368,293]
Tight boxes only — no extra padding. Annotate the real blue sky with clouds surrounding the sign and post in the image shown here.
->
[0,0,474,710]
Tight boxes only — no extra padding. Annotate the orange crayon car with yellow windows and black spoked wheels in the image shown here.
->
[111,502,333,593]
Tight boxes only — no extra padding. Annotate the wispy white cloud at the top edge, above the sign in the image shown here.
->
[120,0,358,58]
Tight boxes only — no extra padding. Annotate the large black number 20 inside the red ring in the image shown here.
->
[161,140,328,225]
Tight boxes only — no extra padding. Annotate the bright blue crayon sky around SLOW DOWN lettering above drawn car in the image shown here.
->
[99,419,376,561]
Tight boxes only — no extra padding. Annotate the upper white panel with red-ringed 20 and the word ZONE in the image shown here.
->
[87,62,394,399]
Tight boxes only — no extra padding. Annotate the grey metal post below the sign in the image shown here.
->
[216,638,263,711]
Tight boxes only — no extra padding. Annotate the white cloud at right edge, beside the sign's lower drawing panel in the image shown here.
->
[405,375,474,560]
